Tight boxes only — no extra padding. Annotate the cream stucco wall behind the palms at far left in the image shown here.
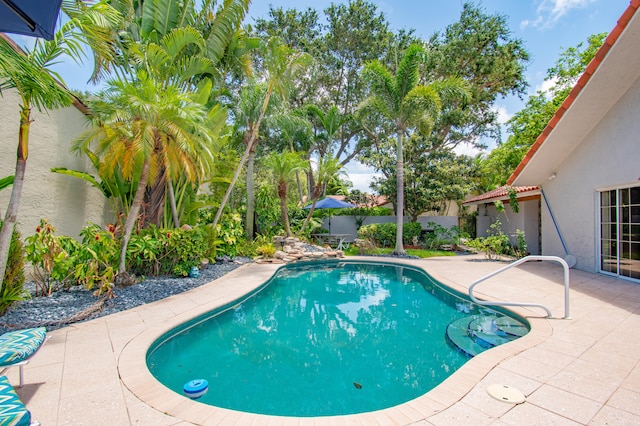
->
[0,91,107,237]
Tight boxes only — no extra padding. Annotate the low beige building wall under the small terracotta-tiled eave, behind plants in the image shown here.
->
[476,200,540,254]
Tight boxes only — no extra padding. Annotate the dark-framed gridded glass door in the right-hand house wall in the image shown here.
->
[600,186,640,280]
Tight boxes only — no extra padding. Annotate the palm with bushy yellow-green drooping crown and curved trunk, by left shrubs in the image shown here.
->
[74,71,226,285]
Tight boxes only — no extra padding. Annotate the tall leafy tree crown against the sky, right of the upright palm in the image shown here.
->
[424,2,529,149]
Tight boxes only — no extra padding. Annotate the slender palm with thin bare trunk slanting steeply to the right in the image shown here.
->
[212,37,311,228]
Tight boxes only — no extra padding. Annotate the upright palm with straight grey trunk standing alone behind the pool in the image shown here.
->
[359,44,469,254]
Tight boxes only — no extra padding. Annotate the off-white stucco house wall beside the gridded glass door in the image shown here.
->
[541,74,640,272]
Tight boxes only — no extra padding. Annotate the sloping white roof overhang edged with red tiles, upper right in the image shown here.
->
[507,0,640,186]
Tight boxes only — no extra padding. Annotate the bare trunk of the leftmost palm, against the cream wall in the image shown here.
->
[0,106,31,289]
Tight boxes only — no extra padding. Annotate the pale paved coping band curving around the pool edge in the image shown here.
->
[117,257,552,424]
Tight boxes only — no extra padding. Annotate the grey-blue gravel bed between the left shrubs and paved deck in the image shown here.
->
[0,257,251,334]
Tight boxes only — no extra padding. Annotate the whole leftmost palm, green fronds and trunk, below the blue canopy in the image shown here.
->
[0,2,117,287]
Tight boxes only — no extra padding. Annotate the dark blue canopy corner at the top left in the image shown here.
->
[0,0,62,40]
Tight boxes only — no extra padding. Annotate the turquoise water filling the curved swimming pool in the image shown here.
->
[147,261,528,417]
